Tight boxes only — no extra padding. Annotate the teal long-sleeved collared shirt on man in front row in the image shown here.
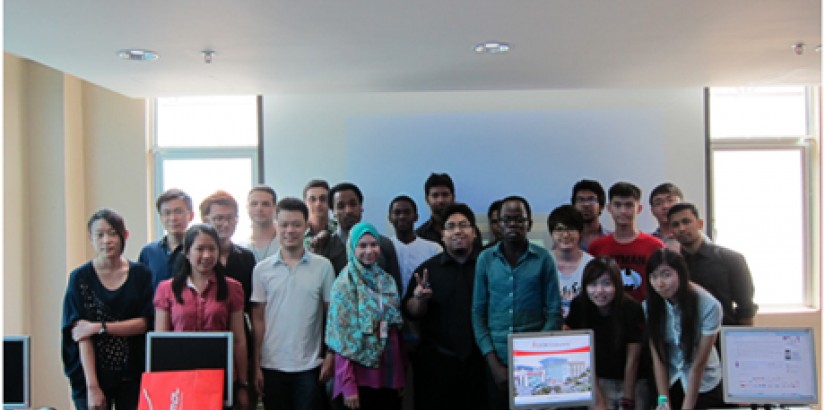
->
[473,243,562,364]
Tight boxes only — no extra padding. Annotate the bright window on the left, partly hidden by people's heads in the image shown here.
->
[153,96,258,242]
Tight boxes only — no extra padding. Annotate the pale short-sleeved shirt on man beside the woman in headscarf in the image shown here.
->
[251,251,335,372]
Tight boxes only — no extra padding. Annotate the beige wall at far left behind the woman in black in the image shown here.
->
[3,54,149,409]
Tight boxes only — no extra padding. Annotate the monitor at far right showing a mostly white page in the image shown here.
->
[720,326,818,405]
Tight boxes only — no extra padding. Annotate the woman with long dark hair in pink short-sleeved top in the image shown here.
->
[154,224,249,410]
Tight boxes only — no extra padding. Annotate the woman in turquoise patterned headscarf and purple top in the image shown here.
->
[326,222,406,410]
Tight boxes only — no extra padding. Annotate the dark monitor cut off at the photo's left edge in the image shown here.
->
[3,336,31,409]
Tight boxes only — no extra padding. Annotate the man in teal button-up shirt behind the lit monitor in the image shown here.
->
[472,196,562,409]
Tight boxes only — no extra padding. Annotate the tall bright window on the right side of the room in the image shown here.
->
[709,87,818,308]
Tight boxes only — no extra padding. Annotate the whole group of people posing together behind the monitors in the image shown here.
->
[63,173,757,410]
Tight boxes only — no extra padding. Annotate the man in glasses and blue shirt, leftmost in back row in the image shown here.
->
[138,188,195,289]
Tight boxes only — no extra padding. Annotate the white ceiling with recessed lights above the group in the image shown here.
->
[4,0,822,97]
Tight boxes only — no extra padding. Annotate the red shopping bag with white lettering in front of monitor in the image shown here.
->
[138,369,224,410]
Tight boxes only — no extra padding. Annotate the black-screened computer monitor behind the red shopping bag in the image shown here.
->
[146,332,234,407]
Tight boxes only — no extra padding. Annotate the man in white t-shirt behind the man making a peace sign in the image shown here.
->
[389,195,443,295]
